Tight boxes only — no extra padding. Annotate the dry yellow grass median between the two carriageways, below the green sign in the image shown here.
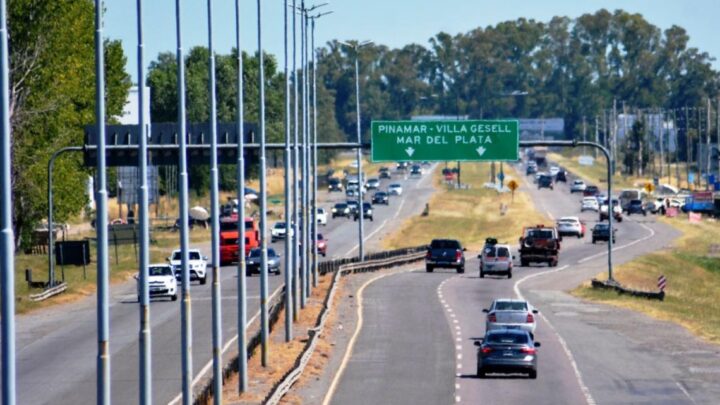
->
[384,163,552,250]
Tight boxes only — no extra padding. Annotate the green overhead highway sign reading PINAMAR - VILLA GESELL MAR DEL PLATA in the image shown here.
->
[371,120,519,162]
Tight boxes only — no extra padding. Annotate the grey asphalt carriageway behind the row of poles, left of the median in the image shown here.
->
[11,163,433,404]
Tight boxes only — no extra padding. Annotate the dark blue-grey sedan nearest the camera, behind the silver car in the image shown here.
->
[475,329,540,379]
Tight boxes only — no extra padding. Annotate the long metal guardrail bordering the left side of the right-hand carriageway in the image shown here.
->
[263,246,426,405]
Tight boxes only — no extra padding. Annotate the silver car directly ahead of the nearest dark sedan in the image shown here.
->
[483,298,538,336]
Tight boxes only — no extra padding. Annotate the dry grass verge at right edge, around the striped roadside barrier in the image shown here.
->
[572,218,720,343]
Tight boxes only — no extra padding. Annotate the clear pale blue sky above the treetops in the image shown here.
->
[104,0,720,82]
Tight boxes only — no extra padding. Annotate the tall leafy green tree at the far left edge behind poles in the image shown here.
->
[8,0,131,247]
